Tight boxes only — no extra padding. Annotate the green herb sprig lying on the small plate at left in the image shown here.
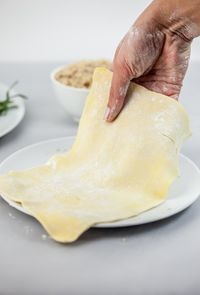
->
[0,81,27,116]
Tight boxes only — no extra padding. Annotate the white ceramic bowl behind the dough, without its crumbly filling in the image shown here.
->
[51,65,89,122]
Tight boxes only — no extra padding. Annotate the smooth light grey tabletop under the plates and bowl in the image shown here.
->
[0,62,200,295]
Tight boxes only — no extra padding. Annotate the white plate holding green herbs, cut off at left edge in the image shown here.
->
[0,83,25,137]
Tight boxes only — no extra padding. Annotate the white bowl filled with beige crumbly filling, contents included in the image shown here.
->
[51,60,111,121]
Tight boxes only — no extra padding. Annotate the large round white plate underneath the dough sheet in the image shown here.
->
[0,137,200,227]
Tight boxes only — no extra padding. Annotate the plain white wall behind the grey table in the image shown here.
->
[0,0,200,62]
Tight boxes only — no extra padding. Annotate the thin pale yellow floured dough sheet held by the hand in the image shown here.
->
[0,68,190,242]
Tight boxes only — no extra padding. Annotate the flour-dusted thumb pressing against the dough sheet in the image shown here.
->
[104,66,130,122]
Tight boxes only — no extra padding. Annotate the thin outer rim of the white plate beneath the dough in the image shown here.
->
[0,135,200,228]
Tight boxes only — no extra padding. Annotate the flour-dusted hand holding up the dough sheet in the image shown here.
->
[105,0,200,122]
